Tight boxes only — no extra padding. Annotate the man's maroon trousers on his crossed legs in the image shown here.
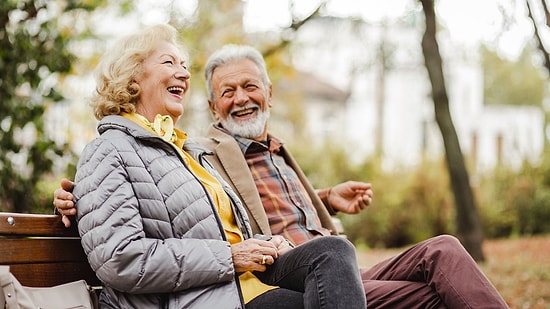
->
[361,235,509,309]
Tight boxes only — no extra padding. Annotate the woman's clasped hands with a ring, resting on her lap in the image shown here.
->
[231,238,279,273]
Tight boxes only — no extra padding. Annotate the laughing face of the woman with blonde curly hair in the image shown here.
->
[136,42,191,122]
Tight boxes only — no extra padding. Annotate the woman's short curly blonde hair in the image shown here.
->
[90,24,187,120]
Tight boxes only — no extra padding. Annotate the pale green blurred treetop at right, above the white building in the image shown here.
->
[481,46,546,106]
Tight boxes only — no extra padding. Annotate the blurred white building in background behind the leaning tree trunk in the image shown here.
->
[280,16,544,169]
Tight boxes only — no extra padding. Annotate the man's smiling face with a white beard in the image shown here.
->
[208,59,271,141]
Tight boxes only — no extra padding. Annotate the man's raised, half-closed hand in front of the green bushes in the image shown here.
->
[327,181,373,214]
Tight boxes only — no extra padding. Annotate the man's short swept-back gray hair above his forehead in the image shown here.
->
[204,44,271,102]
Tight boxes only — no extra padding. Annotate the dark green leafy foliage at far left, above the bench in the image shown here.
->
[0,0,102,212]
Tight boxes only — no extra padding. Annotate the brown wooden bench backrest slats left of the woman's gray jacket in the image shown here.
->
[0,212,101,292]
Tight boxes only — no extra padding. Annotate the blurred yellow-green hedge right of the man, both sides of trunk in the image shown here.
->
[291,136,550,248]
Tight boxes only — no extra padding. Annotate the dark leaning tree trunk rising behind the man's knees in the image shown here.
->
[420,0,485,261]
